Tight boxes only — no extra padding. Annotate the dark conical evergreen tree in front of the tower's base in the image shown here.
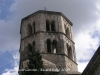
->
[24,47,44,75]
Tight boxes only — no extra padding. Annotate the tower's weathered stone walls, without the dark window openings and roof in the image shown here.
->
[20,10,77,74]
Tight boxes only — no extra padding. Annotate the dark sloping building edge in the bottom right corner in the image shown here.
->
[82,46,100,75]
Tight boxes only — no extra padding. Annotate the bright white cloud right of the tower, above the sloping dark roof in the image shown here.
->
[75,0,100,61]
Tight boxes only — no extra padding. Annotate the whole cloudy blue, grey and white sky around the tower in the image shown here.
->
[0,0,100,75]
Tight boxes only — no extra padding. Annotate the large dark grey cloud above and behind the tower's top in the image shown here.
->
[0,0,98,50]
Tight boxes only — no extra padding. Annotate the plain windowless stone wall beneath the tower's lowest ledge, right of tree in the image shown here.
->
[42,54,78,72]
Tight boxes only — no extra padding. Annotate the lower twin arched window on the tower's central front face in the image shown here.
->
[47,39,57,53]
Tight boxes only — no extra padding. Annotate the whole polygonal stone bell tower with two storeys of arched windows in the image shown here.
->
[19,10,78,75]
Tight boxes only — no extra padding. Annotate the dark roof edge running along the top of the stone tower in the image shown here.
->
[22,10,73,25]
